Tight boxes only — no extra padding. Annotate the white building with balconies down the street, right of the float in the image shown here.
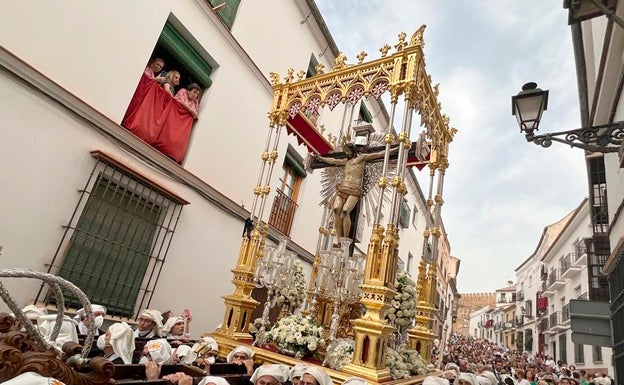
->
[516,199,613,372]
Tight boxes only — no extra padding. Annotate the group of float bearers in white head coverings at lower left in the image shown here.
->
[6,304,367,385]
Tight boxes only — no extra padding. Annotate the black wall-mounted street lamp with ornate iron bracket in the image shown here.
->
[511,83,624,153]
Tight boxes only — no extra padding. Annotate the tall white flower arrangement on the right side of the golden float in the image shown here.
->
[386,271,416,330]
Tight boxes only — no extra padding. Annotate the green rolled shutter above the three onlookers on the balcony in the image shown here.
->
[158,22,212,88]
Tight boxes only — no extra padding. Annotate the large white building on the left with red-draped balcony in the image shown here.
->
[0,0,442,338]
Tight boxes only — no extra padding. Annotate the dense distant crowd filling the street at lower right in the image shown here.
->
[423,334,612,385]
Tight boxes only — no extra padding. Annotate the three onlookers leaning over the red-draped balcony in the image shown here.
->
[143,57,202,118]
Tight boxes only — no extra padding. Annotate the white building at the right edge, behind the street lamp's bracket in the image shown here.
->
[564,1,624,383]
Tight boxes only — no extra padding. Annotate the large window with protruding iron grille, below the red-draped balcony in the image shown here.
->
[38,153,186,317]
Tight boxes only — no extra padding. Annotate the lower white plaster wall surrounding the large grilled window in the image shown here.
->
[0,70,241,336]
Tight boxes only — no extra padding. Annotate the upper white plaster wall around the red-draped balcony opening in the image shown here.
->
[0,0,272,207]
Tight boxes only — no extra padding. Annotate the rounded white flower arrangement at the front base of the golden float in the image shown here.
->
[266,314,325,358]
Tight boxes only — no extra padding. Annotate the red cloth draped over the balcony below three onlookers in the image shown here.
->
[121,75,193,163]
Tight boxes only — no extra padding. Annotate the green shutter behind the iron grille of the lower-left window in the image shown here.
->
[59,177,162,316]
